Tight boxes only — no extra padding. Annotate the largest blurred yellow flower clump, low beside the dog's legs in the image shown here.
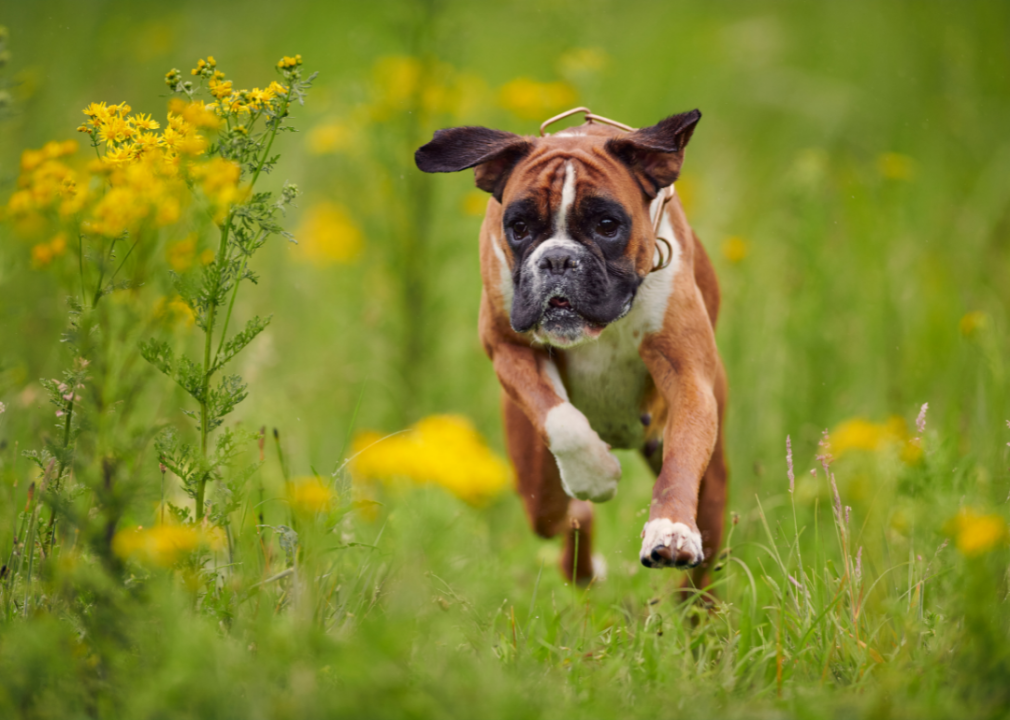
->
[350,415,511,506]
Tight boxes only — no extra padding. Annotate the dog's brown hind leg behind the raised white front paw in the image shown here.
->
[502,392,593,584]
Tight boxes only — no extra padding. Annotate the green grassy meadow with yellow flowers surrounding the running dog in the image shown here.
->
[0,0,1010,718]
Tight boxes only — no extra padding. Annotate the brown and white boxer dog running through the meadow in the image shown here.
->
[415,110,726,586]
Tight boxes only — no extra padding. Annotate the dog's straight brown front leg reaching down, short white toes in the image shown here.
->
[639,308,719,568]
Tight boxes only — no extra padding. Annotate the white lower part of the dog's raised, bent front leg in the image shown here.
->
[544,403,621,503]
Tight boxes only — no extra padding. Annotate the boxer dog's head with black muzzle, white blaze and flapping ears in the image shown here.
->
[415,110,701,347]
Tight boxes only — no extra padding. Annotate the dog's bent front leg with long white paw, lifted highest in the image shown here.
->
[490,341,621,503]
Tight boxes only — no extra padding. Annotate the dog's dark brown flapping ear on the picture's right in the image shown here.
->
[606,110,701,198]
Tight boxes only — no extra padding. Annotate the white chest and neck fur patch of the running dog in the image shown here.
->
[565,262,679,448]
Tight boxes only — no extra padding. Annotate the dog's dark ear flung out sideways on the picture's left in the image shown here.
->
[414,127,533,202]
